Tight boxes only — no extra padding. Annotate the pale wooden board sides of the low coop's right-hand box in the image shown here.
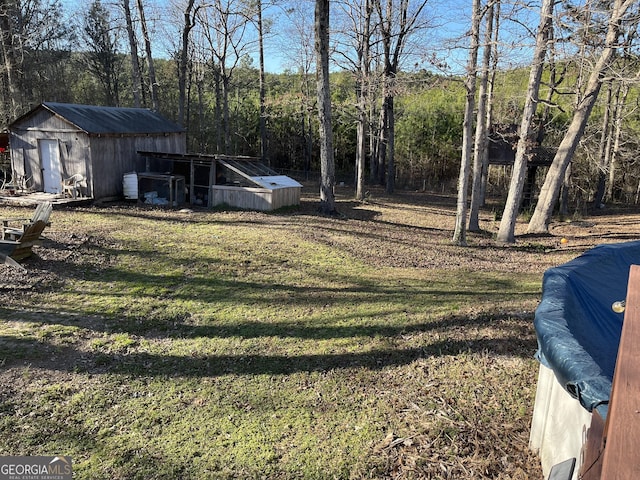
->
[210,185,300,211]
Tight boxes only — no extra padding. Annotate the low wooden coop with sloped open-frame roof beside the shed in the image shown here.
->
[135,151,302,211]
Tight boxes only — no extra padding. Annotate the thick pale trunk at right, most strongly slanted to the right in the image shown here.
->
[527,0,635,233]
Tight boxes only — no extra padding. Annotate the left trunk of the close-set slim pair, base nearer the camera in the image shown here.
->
[453,0,480,247]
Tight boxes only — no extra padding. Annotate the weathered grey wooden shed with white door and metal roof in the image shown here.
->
[9,102,186,199]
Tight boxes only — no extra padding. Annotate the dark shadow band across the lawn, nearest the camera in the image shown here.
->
[0,337,534,377]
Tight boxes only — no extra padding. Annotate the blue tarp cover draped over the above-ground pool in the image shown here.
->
[534,241,640,417]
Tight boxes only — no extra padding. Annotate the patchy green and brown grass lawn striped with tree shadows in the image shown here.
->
[0,189,612,479]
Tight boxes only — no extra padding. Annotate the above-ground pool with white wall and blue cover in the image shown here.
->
[529,241,640,479]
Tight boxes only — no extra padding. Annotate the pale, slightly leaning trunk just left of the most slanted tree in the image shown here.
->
[497,0,554,243]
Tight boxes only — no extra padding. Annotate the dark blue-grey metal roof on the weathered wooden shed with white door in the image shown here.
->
[13,102,184,134]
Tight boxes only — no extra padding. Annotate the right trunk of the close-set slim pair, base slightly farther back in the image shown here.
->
[469,0,494,232]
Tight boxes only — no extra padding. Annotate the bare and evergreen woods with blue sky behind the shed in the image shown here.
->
[0,0,640,236]
